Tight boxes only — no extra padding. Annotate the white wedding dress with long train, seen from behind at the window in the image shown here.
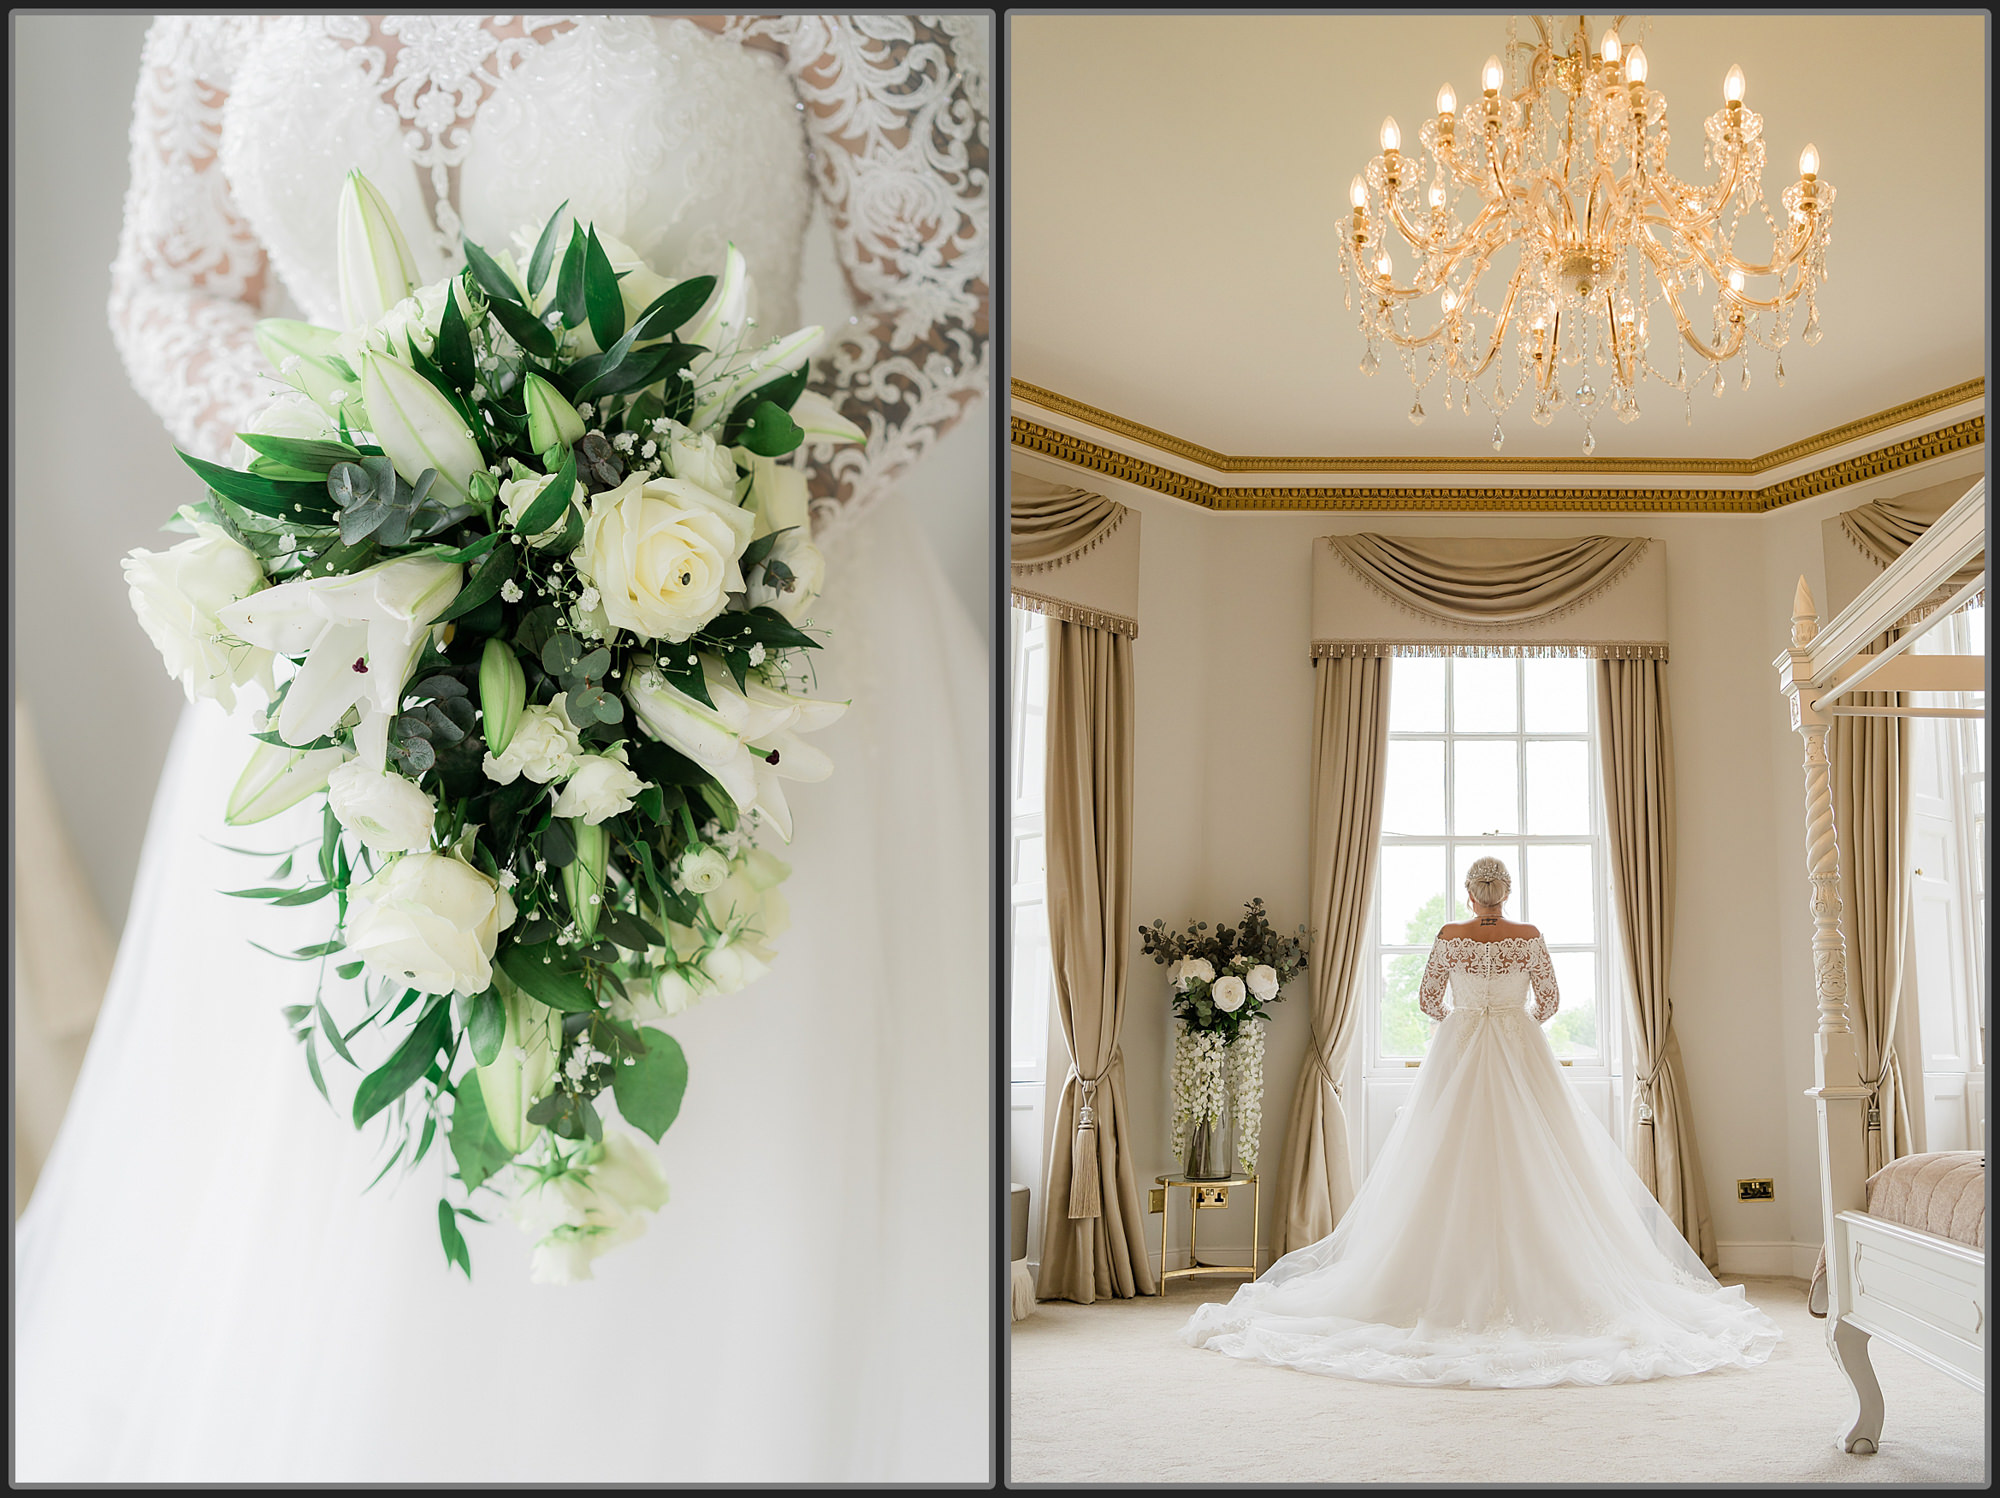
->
[1182,936,1780,1388]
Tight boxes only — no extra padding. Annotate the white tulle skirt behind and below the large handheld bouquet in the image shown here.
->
[14,500,992,1482]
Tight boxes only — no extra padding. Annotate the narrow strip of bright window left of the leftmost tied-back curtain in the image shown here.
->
[1008,608,1052,1084]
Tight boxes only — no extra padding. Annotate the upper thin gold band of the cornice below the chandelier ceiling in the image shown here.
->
[1008,378,1986,482]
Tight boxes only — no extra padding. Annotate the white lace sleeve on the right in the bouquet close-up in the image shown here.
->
[722,16,990,524]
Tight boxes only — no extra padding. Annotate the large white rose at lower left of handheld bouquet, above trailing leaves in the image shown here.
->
[348,852,514,998]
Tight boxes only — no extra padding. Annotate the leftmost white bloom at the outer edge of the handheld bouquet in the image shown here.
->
[124,526,272,712]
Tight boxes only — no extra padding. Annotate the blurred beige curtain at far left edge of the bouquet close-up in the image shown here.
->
[14,700,112,1216]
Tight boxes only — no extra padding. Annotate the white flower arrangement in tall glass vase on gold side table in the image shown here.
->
[1138,900,1306,1178]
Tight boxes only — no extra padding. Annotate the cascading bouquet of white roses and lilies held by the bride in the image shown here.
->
[124,172,862,1280]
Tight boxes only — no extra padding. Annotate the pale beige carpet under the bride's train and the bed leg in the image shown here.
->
[1010,1276,1986,1484]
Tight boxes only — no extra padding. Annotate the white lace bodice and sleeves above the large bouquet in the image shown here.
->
[110,14,988,524]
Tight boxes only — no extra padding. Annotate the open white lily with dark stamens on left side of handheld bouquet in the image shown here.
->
[218,556,462,770]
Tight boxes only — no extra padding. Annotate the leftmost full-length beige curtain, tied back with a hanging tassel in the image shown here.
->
[1038,618,1154,1304]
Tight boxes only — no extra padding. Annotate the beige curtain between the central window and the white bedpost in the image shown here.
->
[1598,660,1718,1268]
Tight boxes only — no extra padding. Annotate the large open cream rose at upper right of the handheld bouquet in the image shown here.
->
[572,474,754,642]
